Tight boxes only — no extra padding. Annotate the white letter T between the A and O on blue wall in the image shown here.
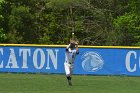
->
[19,49,31,68]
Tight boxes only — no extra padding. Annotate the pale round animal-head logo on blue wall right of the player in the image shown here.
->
[82,52,104,72]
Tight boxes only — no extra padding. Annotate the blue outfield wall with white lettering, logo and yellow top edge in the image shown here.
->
[0,45,140,76]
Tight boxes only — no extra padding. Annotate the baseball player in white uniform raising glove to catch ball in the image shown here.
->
[64,43,79,86]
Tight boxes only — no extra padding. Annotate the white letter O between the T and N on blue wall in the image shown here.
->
[33,49,45,69]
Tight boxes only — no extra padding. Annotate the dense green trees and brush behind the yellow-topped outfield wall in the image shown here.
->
[0,0,140,45]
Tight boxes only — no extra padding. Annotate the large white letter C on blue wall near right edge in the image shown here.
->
[125,51,137,72]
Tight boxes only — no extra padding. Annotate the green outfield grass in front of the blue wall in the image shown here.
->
[0,73,140,93]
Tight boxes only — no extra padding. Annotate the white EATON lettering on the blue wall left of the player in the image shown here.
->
[0,48,59,69]
